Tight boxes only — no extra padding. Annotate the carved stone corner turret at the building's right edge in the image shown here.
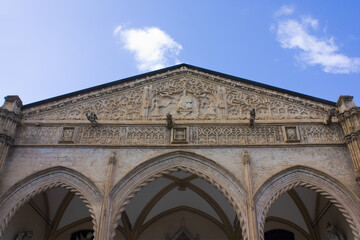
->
[337,96,360,185]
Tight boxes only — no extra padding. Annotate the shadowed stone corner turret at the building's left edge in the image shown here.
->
[0,96,22,168]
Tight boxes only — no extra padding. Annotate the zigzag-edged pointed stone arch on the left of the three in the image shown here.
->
[0,167,103,239]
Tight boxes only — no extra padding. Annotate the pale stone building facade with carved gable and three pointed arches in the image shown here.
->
[0,64,360,240]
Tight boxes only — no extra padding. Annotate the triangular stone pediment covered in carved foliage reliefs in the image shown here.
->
[23,64,334,122]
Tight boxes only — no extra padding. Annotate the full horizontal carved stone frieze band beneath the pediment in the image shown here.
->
[15,124,345,146]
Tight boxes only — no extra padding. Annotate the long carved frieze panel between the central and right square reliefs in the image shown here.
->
[190,126,283,145]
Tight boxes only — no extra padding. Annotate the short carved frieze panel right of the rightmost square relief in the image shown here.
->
[299,124,344,143]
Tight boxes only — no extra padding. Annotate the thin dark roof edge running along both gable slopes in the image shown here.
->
[22,63,336,109]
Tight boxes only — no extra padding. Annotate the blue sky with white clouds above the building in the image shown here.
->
[0,0,360,106]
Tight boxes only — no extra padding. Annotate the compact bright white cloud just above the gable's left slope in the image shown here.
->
[114,26,182,71]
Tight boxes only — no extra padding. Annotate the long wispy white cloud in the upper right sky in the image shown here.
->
[274,7,360,73]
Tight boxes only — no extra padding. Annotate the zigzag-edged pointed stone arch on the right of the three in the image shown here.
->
[254,166,360,240]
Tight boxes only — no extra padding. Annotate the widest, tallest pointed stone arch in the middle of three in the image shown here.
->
[108,151,249,240]
